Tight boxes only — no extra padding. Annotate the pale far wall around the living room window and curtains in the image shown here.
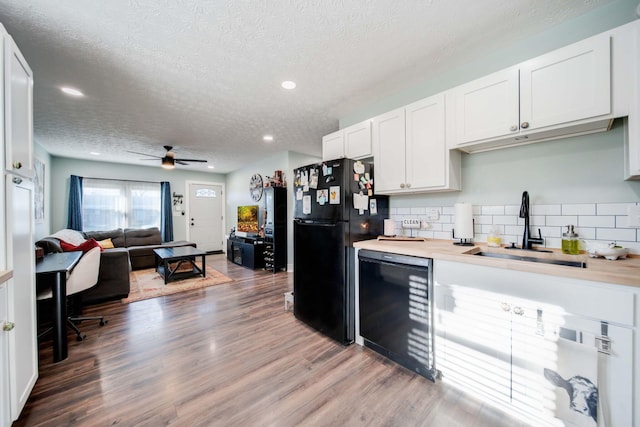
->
[47,156,226,244]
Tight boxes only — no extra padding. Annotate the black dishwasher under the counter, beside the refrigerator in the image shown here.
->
[358,249,435,381]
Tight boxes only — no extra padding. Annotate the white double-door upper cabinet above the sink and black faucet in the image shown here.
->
[453,34,612,152]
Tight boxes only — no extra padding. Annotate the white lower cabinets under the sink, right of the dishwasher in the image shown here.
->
[434,259,639,426]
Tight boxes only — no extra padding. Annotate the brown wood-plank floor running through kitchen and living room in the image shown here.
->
[13,255,520,427]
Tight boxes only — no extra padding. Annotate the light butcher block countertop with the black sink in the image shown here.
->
[353,240,640,288]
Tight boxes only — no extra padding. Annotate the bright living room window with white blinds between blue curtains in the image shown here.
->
[82,178,160,231]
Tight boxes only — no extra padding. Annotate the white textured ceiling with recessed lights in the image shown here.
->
[0,0,610,173]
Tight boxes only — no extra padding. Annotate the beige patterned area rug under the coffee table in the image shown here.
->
[122,266,233,303]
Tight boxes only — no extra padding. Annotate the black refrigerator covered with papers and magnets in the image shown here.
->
[293,159,389,345]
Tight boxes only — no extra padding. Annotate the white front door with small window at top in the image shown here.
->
[187,182,224,252]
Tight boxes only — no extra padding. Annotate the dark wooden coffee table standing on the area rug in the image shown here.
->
[153,246,207,284]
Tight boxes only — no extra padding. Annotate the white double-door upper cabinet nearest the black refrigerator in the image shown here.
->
[372,94,460,194]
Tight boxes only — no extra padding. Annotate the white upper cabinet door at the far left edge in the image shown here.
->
[3,33,34,178]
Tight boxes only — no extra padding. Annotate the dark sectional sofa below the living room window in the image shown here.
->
[36,227,196,305]
